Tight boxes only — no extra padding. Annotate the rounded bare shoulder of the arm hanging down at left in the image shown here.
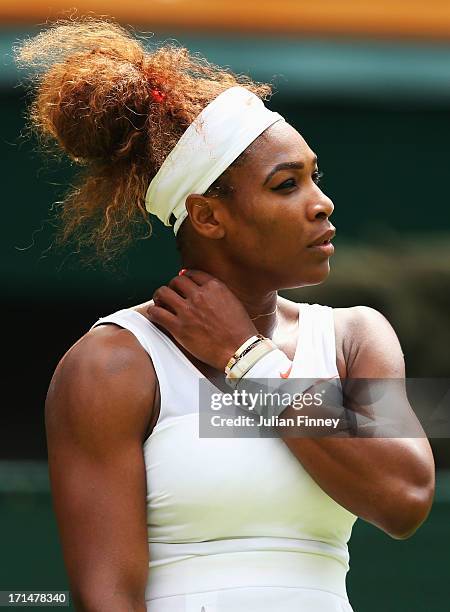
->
[46,324,156,448]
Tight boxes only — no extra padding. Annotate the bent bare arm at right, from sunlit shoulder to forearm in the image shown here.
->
[283,307,434,538]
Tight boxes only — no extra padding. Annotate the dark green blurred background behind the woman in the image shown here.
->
[0,3,450,612]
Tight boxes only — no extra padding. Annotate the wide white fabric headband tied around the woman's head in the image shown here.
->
[145,85,284,235]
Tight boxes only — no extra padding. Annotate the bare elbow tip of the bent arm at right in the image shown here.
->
[380,481,434,540]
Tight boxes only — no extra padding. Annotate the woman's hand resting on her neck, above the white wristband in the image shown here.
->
[147,270,258,370]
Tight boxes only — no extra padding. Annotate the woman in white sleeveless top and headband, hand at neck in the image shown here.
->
[19,20,434,612]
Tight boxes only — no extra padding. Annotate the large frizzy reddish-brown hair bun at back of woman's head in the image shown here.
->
[19,20,150,163]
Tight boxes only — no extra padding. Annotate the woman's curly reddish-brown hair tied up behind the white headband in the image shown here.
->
[16,17,272,261]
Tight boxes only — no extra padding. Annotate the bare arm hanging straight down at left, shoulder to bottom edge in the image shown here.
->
[46,325,156,612]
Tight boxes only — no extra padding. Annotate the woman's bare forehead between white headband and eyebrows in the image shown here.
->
[248,121,315,171]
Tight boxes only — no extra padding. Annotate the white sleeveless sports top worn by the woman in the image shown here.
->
[92,304,356,610]
